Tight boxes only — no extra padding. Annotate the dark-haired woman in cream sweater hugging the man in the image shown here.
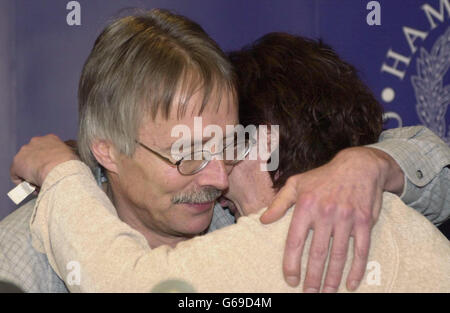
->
[11,33,450,292]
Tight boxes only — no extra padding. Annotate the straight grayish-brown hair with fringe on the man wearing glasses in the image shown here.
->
[78,9,235,170]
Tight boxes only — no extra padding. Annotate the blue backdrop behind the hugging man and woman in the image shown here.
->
[0,0,450,218]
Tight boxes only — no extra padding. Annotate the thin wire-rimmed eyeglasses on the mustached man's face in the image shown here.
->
[136,139,255,176]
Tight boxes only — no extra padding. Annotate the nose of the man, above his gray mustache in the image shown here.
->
[197,158,230,190]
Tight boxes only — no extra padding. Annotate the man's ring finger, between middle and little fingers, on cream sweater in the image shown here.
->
[323,223,352,292]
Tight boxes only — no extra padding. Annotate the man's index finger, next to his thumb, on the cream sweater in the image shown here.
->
[283,206,310,287]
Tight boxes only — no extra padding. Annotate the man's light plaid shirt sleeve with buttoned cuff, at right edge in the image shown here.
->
[369,126,450,225]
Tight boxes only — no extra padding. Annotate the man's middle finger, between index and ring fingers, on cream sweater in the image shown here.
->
[303,225,331,292]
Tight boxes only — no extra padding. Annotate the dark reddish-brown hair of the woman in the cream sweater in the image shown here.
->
[229,33,383,189]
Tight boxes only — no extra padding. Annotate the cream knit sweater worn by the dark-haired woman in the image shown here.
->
[31,161,450,293]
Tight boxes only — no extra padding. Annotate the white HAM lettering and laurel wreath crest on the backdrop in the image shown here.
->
[381,0,450,145]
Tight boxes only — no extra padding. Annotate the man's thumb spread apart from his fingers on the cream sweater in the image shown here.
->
[260,182,297,224]
